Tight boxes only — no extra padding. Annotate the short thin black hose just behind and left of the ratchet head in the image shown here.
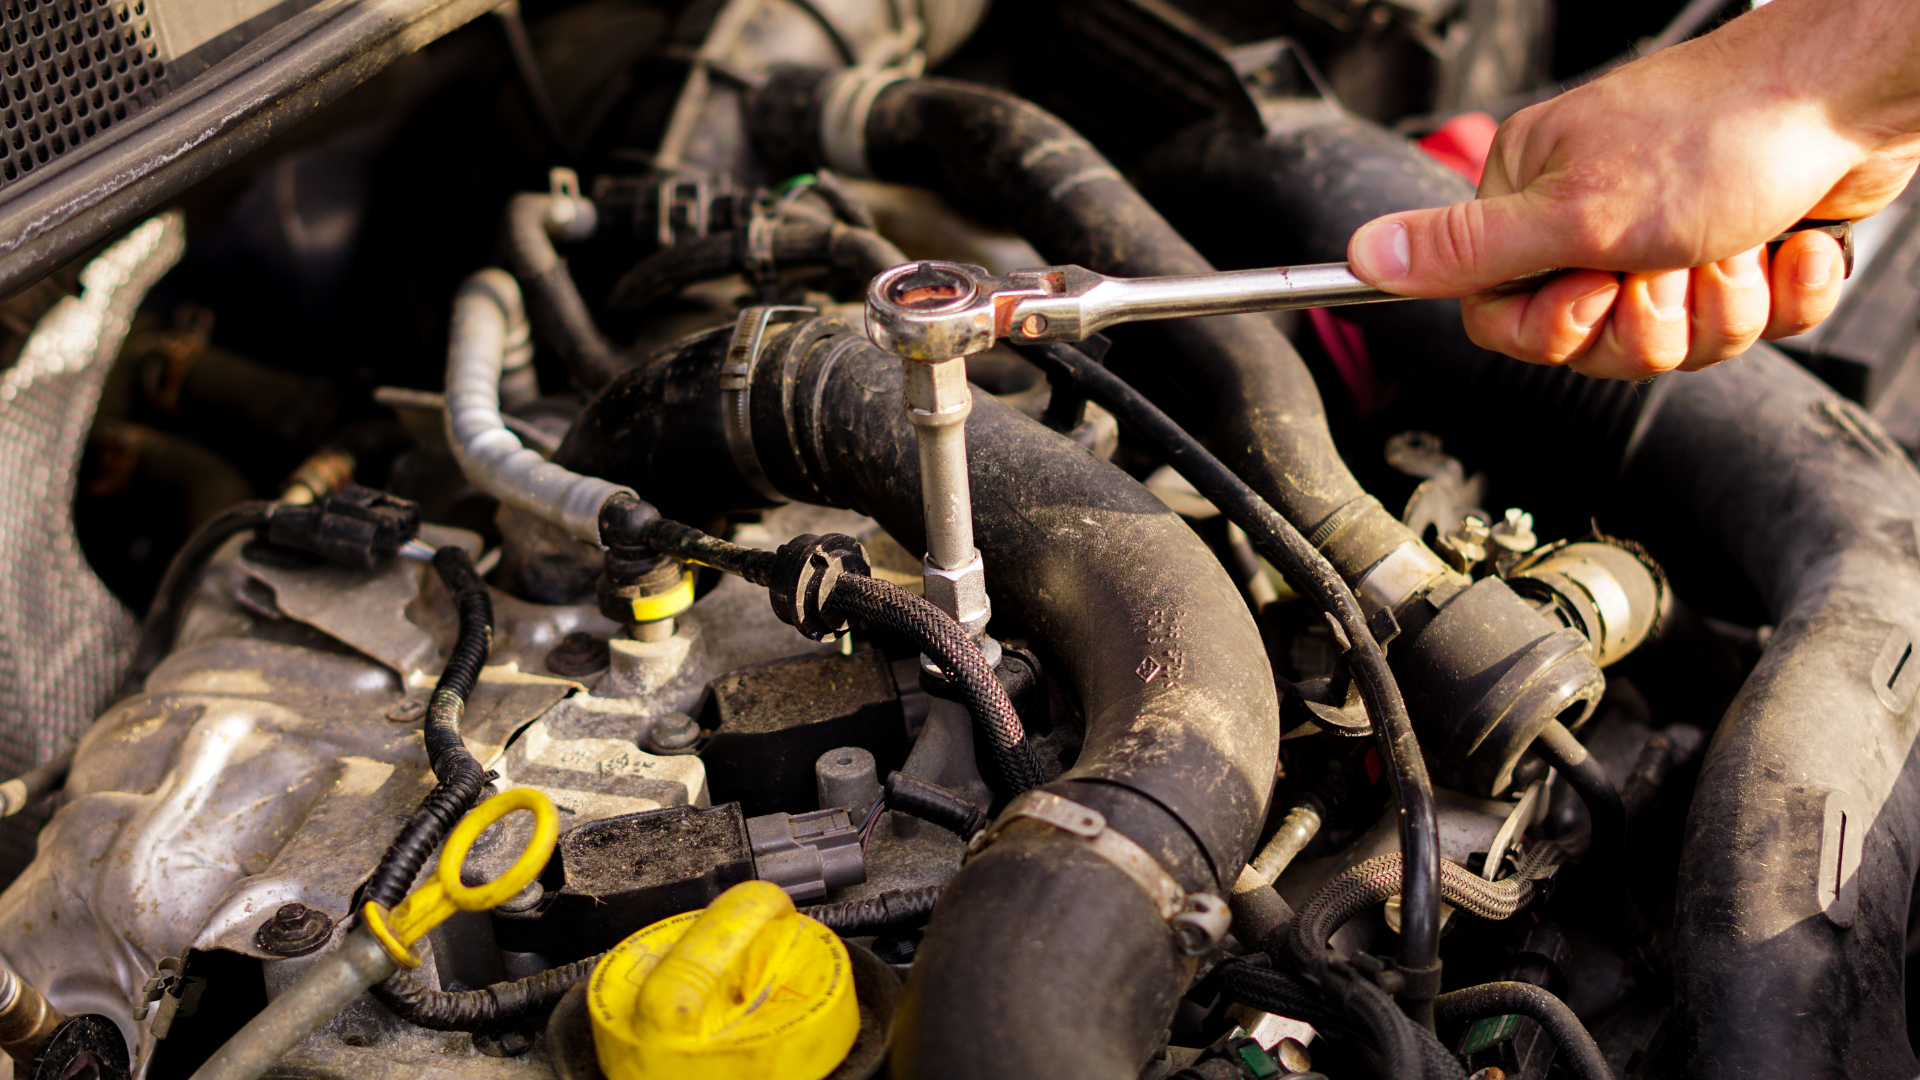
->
[607,221,906,311]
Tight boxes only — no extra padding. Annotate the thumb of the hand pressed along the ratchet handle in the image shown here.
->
[1346,192,1580,296]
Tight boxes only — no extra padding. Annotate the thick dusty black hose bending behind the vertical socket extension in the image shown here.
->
[557,311,1279,1080]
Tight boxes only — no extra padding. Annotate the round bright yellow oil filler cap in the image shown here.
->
[588,882,860,1080]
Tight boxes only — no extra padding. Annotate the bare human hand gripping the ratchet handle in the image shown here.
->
[1348,0,1920,379]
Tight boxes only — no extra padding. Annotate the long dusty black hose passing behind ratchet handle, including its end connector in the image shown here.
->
[749,69,1605,794]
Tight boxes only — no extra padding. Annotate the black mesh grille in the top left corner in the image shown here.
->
[0,0,167,188]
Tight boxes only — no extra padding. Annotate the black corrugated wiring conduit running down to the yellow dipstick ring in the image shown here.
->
[365,548,493,907]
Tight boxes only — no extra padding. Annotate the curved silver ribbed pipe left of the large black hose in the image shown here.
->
[447,269,632,544]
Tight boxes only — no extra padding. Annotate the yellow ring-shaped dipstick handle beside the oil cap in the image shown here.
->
[361,776,561,967]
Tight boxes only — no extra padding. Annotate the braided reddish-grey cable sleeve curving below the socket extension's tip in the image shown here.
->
[822,575,1041,794]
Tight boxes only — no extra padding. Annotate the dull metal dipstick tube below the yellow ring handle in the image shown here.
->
[192,926,399,1080]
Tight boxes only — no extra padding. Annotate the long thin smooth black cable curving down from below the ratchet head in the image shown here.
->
[1018,344,1440,1026]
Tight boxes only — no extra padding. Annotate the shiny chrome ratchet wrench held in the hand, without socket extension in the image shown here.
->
[866,221,1853,363]
